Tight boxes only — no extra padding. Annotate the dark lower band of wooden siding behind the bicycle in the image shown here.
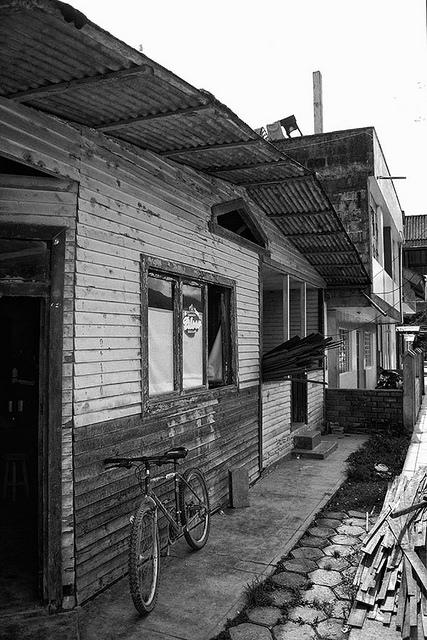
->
[75,387,258,603]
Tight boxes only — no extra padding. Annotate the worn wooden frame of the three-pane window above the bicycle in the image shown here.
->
[141,254,238,412]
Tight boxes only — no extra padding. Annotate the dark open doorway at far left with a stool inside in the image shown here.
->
[0,296,42,610]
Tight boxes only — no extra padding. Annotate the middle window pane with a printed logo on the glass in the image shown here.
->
[182,284,203,389]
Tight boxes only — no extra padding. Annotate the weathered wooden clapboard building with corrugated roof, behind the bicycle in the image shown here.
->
[0,0,366,609]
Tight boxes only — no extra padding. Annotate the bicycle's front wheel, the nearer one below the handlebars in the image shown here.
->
[129,503,160,615]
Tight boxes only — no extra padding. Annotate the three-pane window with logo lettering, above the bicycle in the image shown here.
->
[143,258,235,399]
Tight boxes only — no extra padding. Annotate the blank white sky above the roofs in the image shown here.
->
[72,0,427,215]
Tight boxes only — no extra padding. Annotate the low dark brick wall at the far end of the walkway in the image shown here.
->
[326,389,403,432]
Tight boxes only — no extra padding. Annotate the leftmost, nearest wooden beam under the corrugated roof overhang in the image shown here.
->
[7,64,154,102]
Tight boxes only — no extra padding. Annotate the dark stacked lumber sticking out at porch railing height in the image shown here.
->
[262,333,339,381]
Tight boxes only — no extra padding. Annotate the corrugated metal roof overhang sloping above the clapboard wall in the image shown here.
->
[0,0,369,286]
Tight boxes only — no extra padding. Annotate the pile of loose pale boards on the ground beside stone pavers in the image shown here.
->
[348,467,427,640]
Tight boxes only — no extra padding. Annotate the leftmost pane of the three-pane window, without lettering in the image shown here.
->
[148,276,174,396]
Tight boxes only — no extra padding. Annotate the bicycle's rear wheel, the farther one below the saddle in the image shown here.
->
[179,469,211,549]
